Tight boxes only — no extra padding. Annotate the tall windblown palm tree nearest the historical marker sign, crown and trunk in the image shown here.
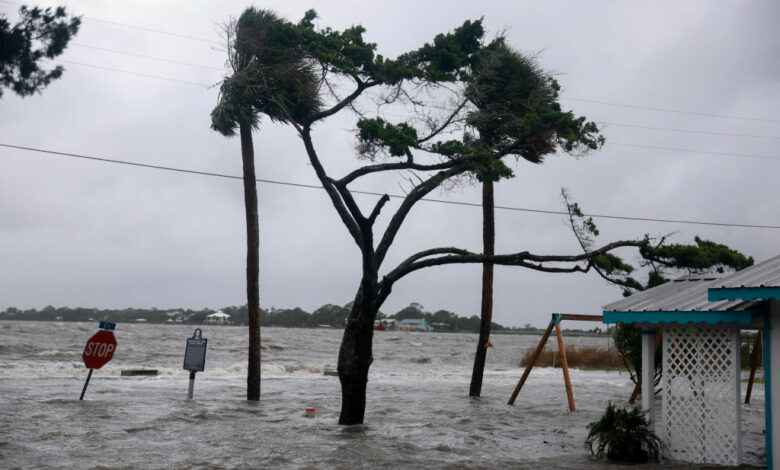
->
[211,8,320,400]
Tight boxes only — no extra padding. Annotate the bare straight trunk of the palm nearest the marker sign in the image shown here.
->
[239,123,260,401]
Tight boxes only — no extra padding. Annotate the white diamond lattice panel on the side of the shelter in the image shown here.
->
[658,325,742,465]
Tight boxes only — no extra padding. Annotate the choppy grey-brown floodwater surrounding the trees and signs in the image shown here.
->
[0,322,764,469]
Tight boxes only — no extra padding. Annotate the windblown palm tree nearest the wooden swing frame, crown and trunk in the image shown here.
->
[465,37,604,396]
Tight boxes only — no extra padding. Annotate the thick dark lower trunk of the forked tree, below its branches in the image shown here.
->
[338,275,379,424]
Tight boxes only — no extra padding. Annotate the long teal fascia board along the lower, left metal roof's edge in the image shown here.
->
[602,310,763,325]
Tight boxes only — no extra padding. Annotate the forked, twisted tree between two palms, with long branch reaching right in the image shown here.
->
[218,10,648,424]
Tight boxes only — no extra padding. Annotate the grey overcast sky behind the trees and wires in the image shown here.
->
[0,0,780,327]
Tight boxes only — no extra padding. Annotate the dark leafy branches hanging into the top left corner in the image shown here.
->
[0,6,81,96]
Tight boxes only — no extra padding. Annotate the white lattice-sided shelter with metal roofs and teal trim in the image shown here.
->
[603,256,780,470]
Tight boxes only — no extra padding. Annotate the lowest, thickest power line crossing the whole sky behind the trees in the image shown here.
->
[0,143,780,229]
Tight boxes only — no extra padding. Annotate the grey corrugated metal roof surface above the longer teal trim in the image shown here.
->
[602,274,756,312]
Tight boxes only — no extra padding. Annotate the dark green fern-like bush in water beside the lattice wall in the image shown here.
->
[585,403,660,462]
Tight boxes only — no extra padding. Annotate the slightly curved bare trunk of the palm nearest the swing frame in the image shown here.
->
[469,180,496,397]
